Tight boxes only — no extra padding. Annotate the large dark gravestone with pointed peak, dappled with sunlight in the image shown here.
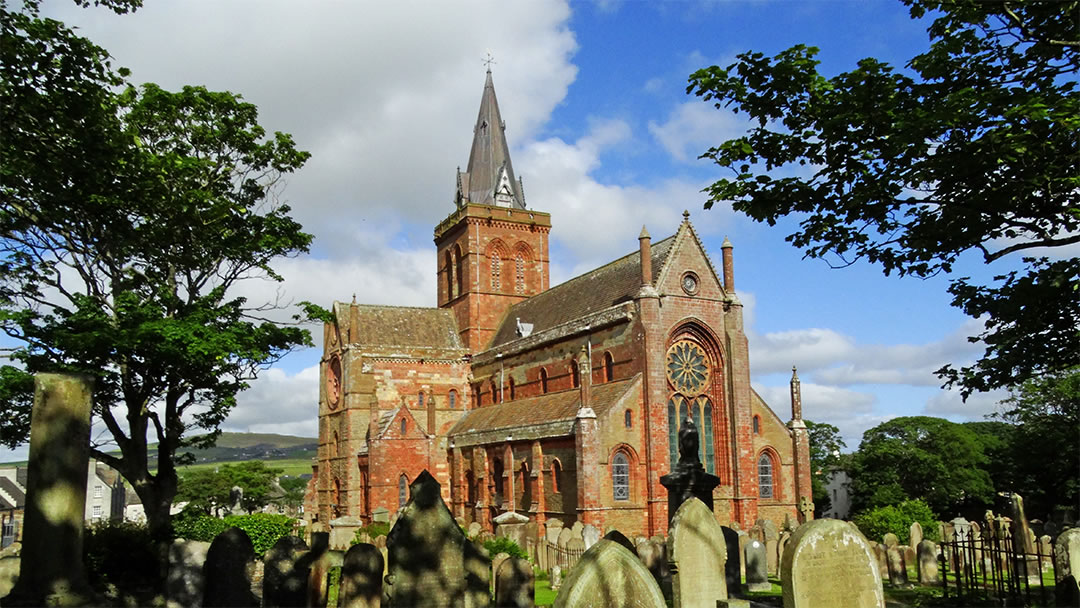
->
[386,471,490,608]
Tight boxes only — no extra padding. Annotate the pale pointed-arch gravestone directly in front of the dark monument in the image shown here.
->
[667,497,728,608]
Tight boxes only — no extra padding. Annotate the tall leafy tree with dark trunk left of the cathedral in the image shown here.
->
[0,2,311,543]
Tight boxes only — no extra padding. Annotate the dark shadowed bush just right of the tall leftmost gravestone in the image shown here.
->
[82,522,160,592]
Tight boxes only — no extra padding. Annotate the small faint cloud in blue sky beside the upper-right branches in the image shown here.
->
[649,99,747,162]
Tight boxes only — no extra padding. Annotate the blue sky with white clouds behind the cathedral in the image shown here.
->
[12,0,1028,452]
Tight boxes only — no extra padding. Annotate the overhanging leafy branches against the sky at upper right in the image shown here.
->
[687,0,1080,398]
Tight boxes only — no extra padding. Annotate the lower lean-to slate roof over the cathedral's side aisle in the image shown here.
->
[447,374,642,446]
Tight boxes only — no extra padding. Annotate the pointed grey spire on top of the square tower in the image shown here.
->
[457,66,525,208]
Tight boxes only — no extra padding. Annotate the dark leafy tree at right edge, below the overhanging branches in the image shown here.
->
[997,367,1080,517]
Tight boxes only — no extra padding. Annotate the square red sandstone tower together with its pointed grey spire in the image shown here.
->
[435,70,551,352]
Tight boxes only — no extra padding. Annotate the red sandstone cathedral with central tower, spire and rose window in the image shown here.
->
[307,71,813,538]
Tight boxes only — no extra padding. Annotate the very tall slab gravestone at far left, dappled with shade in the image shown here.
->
[2,374,95,606]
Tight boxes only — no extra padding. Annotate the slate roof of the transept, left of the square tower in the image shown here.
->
[336,302,464,349]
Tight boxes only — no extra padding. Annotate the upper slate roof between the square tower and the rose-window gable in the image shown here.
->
[489,234,676,348]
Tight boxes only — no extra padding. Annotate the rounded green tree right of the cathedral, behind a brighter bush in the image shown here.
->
[851,416,995,516]
